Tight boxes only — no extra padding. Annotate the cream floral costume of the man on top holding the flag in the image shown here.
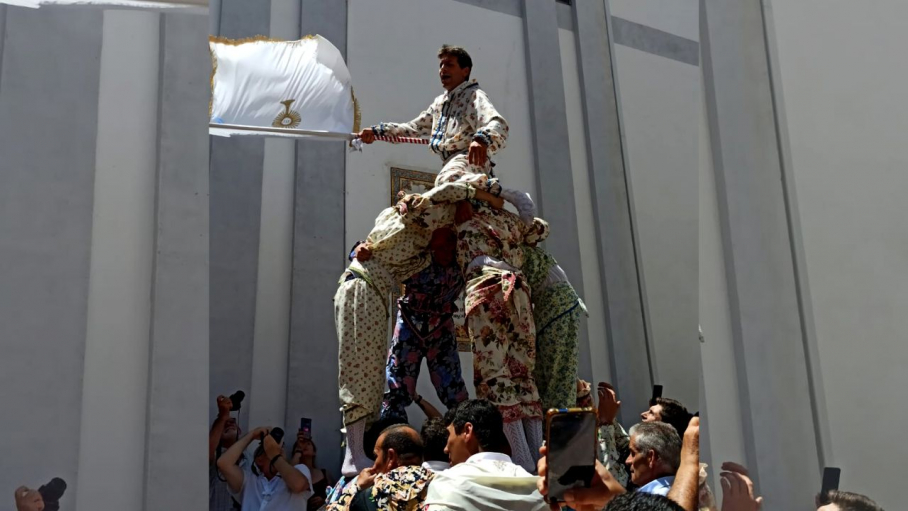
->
[372,80,508,189]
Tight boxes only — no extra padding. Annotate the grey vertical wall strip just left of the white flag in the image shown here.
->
[144,14,210,510]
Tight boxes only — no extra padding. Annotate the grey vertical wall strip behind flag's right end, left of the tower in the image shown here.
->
[286,0,349,474]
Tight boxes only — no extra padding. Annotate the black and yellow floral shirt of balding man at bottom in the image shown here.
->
[327,465,435,511]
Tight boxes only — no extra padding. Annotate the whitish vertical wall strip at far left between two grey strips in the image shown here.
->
[75,11,160,510]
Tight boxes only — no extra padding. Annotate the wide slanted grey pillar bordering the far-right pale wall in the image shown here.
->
[701,0,825,509]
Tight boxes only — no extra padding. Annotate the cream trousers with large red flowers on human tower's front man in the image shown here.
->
[465,266,542,423]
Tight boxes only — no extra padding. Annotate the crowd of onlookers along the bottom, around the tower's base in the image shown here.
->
[209,388,881,511]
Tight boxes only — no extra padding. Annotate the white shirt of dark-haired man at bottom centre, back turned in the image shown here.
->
[425,452,549,511]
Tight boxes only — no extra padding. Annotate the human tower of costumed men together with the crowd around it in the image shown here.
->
[209,46,888,511]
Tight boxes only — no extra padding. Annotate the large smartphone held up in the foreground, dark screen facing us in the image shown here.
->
[545,408,596,504]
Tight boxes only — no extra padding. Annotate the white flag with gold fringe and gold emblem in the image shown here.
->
[209,35,359,139]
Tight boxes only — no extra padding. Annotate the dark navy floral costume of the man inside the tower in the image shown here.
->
[381,262,469,421]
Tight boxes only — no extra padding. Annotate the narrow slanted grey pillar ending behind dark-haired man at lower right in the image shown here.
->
[574,1,655,424]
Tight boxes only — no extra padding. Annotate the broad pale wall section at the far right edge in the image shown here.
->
[771,0,908,509]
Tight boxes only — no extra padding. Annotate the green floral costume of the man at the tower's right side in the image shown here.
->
[522,247,586,409]
